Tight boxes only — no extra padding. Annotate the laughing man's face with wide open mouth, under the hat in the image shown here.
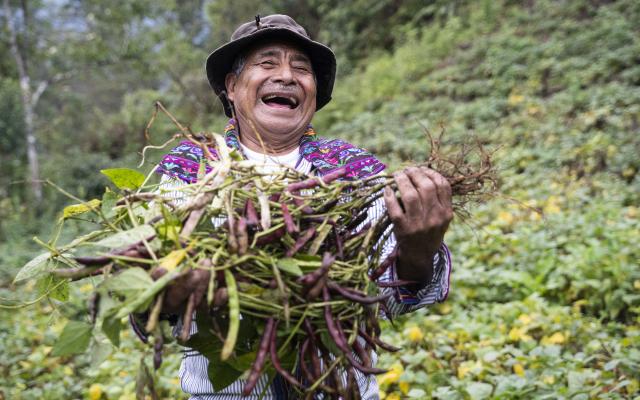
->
[225,42,316,136]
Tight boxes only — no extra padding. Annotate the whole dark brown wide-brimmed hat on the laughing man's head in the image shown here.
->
[206,14,336,117]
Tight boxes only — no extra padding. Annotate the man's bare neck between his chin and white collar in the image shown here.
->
[238,121,304,156]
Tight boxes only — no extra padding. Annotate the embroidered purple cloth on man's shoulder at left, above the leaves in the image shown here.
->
[156,140,217,183]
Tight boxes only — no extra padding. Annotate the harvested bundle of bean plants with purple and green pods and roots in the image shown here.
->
[15,103,496,398]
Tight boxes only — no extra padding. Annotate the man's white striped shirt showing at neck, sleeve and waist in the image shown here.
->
[155,146,451,400]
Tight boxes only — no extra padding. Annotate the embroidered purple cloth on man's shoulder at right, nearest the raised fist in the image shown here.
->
[300,137,386,179]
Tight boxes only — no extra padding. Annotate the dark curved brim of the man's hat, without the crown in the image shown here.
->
[206,27,336,117]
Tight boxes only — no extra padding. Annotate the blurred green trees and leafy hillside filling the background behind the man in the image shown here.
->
[0,0,640,399]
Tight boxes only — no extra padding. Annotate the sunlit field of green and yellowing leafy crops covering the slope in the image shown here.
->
[0,0,640,400]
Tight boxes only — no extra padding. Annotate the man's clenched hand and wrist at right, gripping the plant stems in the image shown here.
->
[384,167,453,286]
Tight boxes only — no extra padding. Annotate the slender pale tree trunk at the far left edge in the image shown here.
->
[4,0,42,204]
